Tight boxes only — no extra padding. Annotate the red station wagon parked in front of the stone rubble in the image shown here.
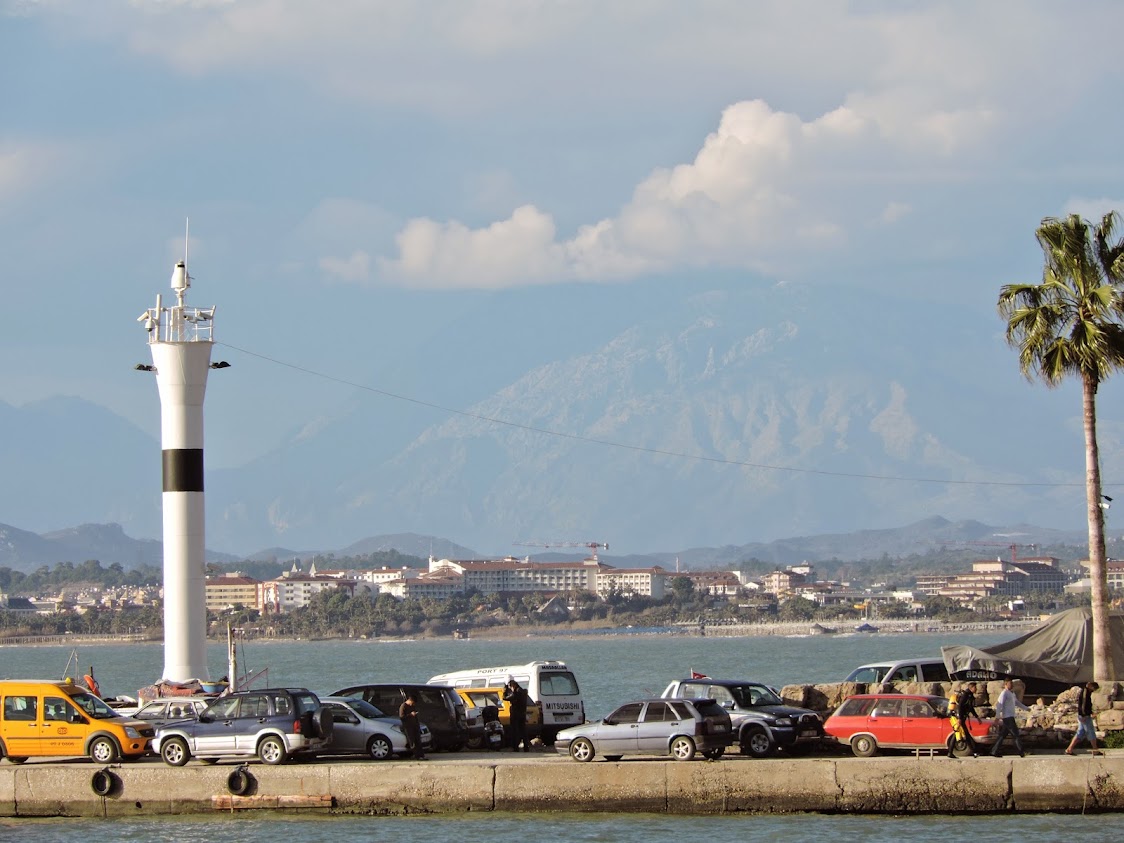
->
[824,694,996,758]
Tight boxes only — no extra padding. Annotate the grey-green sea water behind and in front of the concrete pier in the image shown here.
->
[0,631,1115,843]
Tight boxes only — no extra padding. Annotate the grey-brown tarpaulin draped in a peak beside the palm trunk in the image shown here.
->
[941,608,1124,685]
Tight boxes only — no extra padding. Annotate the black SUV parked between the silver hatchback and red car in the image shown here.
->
[660,677,824,758]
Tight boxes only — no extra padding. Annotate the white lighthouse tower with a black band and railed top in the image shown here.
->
[137,232,228,682]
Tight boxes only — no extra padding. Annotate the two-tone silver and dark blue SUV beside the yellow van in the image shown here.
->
[153,688,333,767]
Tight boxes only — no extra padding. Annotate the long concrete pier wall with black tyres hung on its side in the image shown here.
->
[0,753,1124,817]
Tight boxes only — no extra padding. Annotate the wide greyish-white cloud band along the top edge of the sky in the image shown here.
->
[28,0,1124,121]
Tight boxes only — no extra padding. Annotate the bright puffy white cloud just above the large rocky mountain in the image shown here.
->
[379,100,966,288]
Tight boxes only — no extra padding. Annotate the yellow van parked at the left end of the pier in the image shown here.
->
[0,679,156,764]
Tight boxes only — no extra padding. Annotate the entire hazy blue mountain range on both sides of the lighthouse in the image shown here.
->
[0,280,1124,563]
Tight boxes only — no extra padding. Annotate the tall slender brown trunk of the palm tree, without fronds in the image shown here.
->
[1081,375,1114,682]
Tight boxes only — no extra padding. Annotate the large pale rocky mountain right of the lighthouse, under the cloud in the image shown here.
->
[208,282,1122,553]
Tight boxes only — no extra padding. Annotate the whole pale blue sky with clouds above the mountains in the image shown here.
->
[0,0,1124,468]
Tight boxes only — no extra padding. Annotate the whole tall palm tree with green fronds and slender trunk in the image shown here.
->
[998,212,1124,681]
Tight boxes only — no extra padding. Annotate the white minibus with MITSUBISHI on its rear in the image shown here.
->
[429,661,586,745]
